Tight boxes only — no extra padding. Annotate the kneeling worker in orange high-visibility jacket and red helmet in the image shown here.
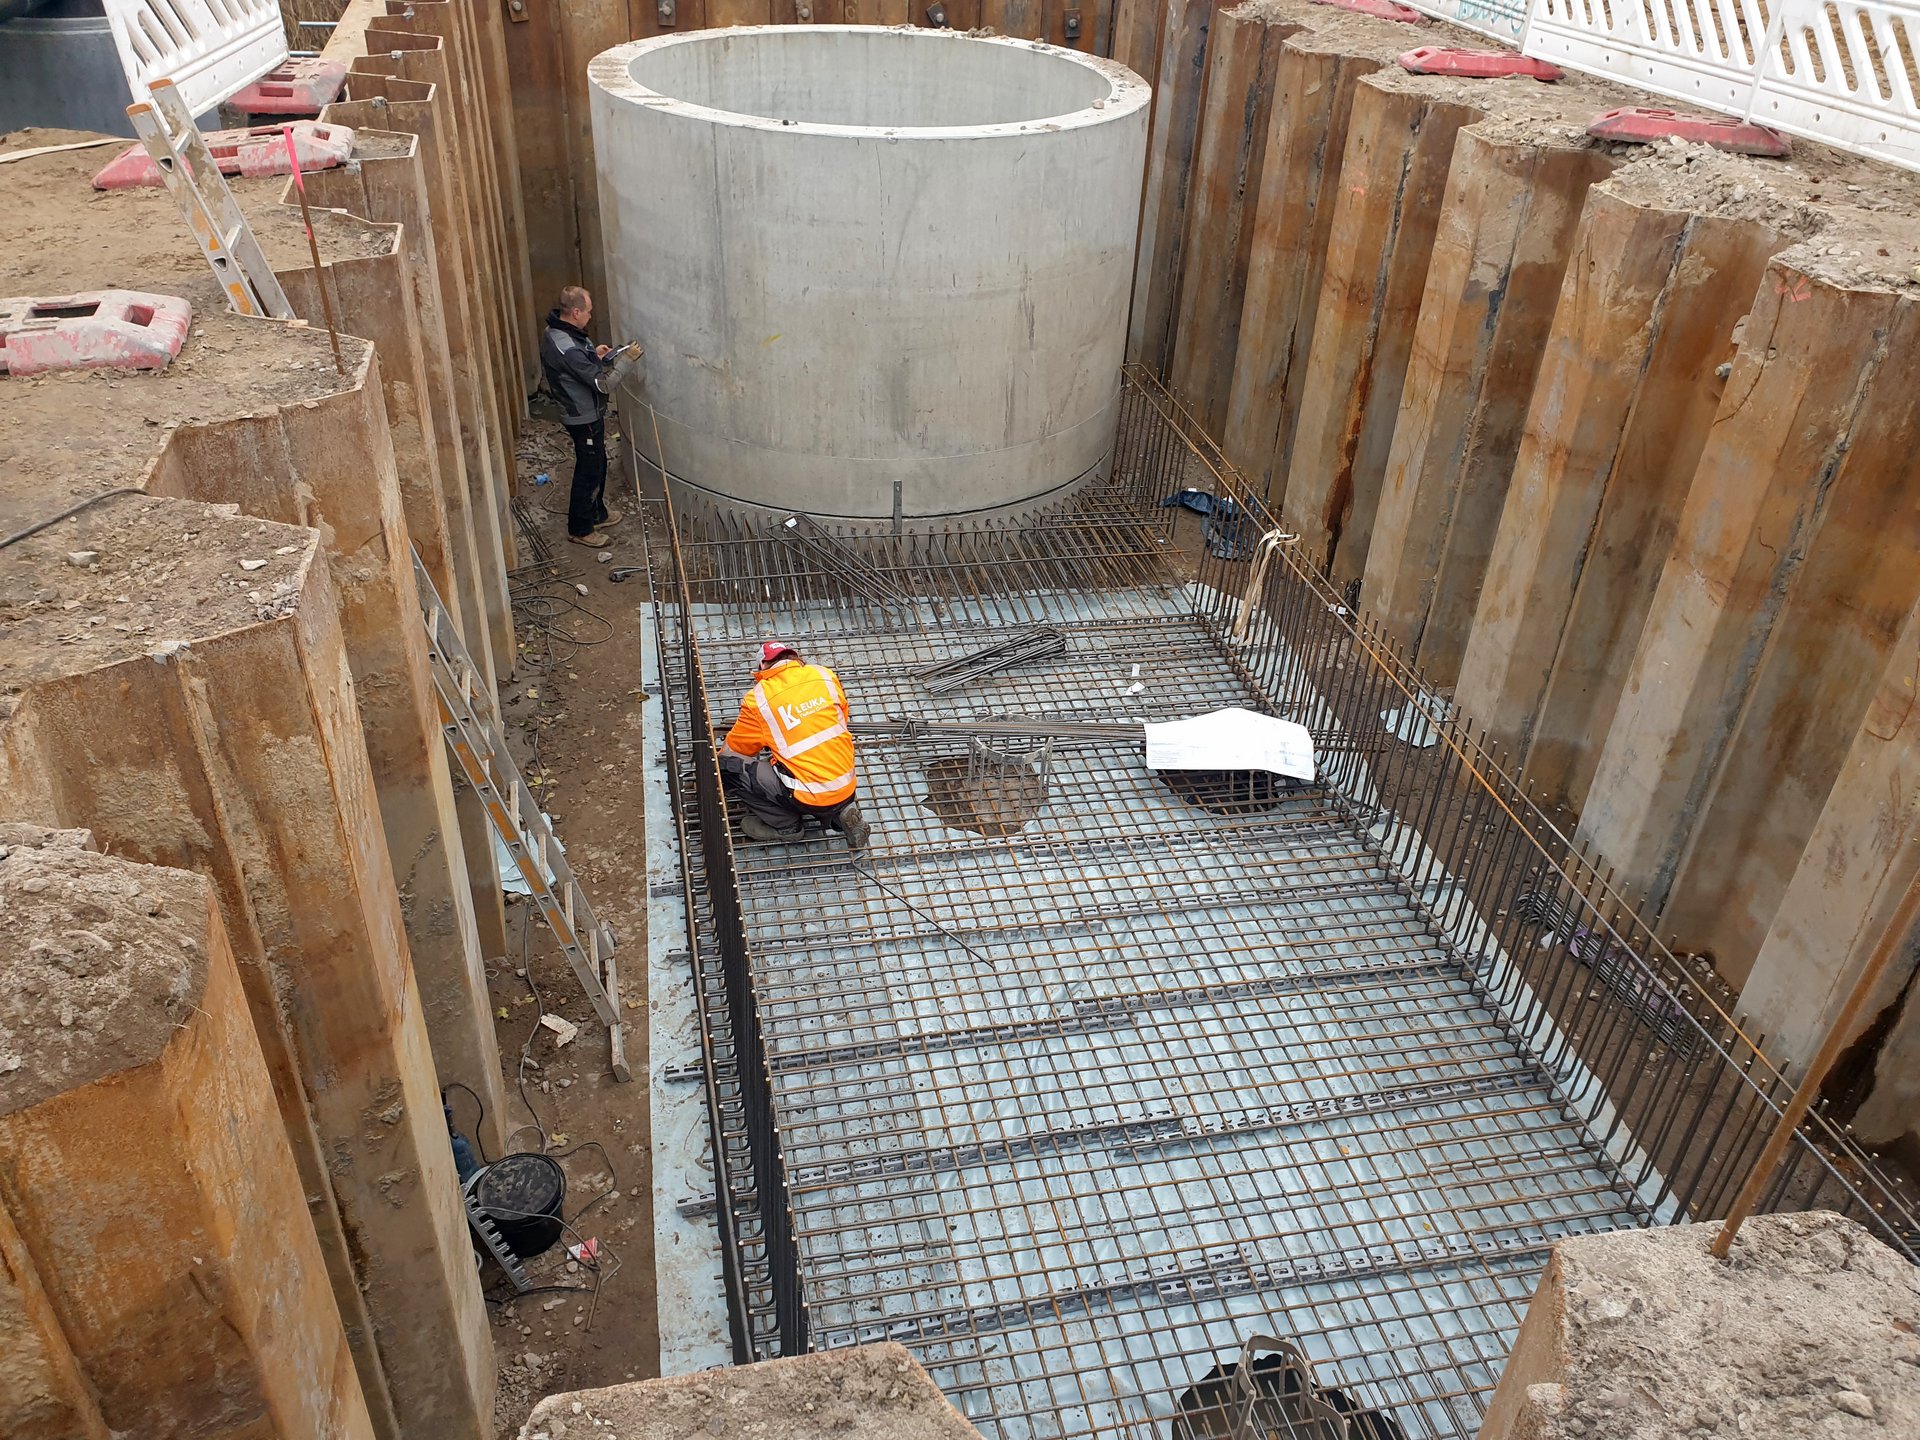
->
[720,639,868,851]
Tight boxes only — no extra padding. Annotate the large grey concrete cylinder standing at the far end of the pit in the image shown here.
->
[591,25,1148,528]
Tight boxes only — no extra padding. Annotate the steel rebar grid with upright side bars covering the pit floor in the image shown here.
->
[651,368,1914,1438]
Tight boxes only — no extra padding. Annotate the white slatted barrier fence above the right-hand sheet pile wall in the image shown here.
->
[1404,0,1920,169]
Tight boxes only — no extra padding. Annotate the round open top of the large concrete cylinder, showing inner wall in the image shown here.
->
[626,25,1116,132]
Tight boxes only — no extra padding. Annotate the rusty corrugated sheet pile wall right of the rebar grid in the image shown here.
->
[1119,0,1920,1175]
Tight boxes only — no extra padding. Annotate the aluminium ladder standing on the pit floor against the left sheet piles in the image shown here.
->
[413,555,632,1081]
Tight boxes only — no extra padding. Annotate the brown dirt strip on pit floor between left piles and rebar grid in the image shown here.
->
[483,419,674,1438]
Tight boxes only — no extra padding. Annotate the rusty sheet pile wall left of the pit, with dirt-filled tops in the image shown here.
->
[0,4,536,1440]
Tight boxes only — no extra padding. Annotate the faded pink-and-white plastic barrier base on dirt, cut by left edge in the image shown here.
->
[0,290,194,374]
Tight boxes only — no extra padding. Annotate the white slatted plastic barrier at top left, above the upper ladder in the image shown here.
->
[106,0,286,115]
